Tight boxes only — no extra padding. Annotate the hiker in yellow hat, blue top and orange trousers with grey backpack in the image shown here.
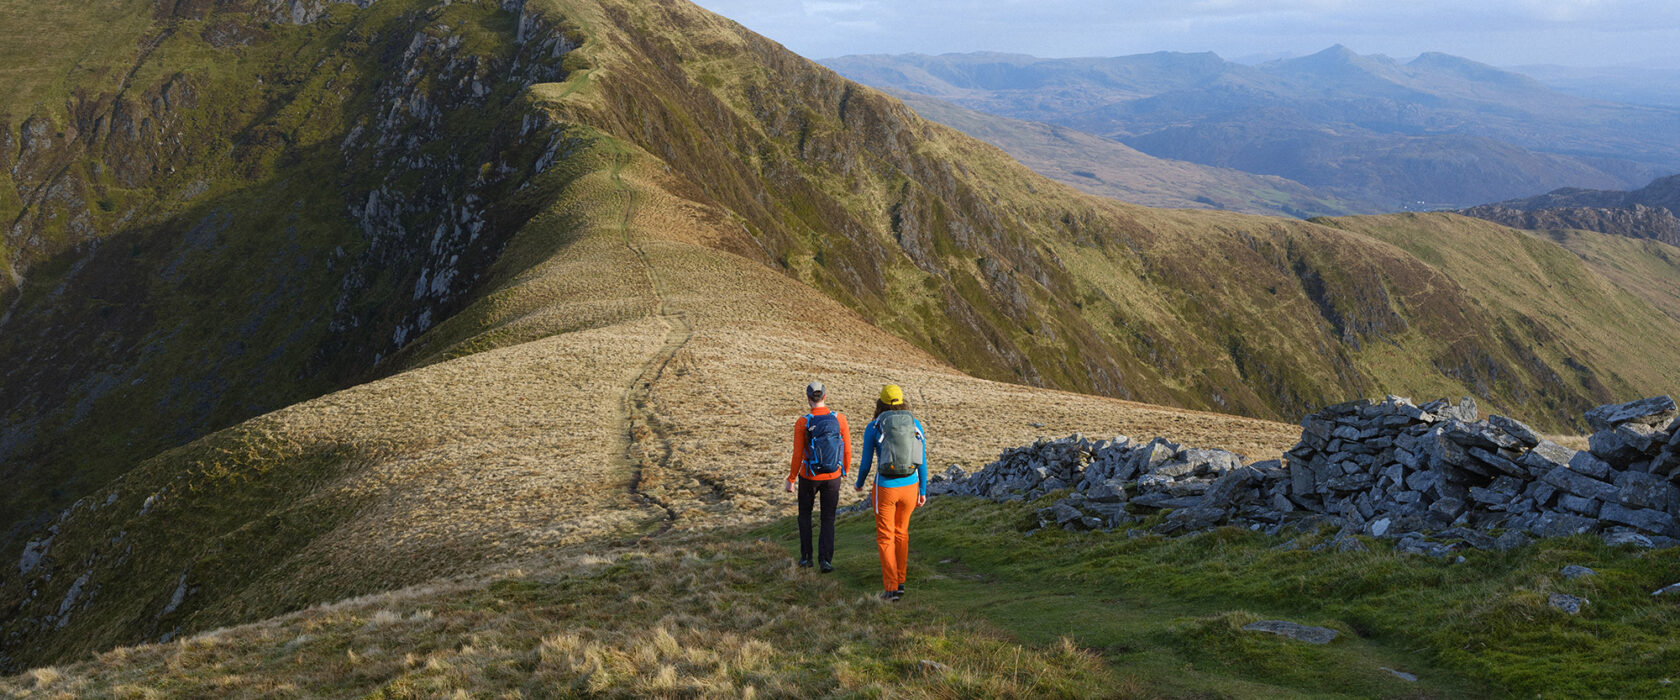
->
[855,384,927,601]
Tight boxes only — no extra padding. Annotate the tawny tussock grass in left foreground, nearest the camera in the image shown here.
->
[0,542,1114,698]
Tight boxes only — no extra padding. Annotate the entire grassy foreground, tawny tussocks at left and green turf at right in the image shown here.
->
[13,499,1680,698]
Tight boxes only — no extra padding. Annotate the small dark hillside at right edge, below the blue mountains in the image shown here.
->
[1460,175,1680,245]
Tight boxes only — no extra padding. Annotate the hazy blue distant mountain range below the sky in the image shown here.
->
[825,45,1680,210]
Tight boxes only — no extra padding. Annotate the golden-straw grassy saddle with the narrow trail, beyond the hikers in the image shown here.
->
[0,133,1295,668]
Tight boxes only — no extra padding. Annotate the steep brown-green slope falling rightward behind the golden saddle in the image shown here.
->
[500,2,1680,428]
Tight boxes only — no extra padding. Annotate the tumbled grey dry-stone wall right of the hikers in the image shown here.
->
[931,396,1680,543]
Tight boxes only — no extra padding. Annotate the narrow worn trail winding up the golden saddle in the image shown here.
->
[612,156,694,537]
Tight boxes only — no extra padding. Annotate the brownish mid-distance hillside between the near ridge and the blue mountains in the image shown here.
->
[889,91,1378,218]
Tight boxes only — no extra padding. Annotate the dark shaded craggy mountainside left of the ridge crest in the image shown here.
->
[0,0,576,533]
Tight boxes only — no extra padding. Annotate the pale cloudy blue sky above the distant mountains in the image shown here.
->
[682,0,1680,69]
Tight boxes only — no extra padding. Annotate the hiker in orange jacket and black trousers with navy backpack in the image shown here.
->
[788,381,852,574]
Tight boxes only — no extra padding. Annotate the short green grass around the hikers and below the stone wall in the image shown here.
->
[756,499,1680,697]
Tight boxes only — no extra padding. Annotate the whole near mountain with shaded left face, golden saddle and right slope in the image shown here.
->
[0,0,1680,678]
